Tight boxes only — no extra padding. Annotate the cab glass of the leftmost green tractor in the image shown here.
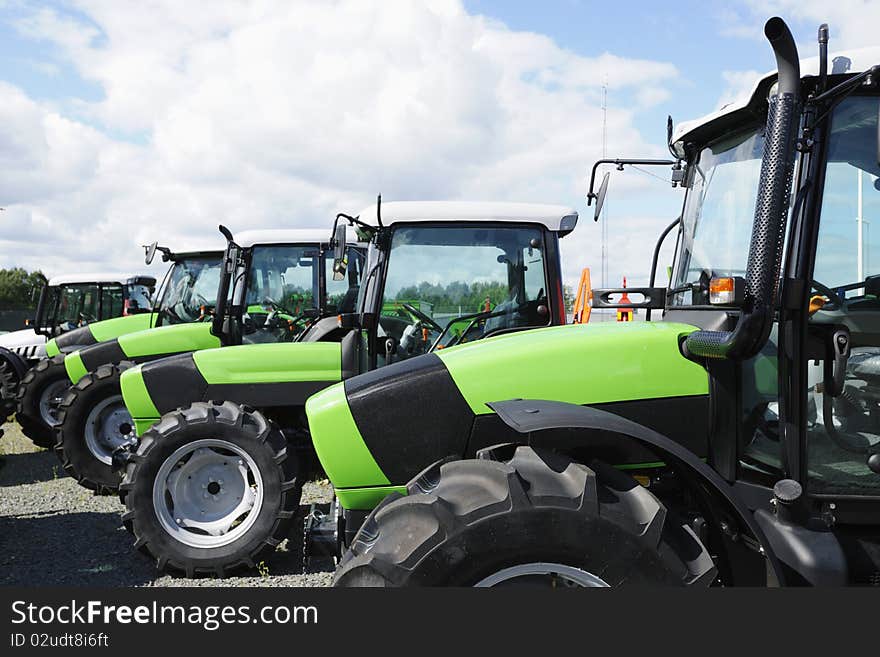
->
[159,257,220,324]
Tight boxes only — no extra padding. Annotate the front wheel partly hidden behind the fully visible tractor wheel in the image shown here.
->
[55,361,134,494]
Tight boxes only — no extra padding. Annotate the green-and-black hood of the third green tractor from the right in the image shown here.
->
[64,315,220,383]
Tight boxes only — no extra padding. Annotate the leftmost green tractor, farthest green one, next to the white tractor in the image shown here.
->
[16,244,223,448]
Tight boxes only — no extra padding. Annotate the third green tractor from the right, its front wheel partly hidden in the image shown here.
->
[55,227,364,493]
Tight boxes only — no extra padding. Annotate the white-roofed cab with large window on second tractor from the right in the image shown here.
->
[337,201,578,371]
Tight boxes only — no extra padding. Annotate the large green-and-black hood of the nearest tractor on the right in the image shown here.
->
[306,322,708,509]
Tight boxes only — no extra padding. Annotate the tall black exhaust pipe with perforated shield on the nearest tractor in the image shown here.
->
[682,17,801,360]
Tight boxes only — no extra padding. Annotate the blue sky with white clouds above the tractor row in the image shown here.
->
[0,0,880,286]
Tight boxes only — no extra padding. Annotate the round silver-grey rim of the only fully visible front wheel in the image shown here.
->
[153,438,263,548]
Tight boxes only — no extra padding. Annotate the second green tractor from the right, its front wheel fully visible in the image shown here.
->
[120,202,577,576]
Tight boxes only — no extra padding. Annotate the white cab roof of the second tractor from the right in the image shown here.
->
[360,201,578,233]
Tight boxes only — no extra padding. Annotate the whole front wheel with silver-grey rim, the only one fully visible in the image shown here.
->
[120,401,302,577]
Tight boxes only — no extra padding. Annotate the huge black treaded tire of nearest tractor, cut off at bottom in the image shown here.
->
[333,446,716,587]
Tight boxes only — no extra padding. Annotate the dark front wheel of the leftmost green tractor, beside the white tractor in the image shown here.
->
[15,354,70,448]
